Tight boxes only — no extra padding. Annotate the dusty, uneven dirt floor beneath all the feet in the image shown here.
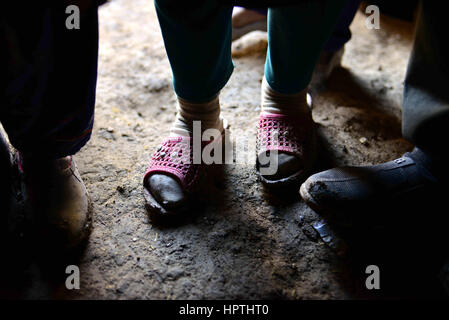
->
[1,0,443,299]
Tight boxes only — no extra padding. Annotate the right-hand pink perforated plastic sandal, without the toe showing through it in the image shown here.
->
[256,113,316,187]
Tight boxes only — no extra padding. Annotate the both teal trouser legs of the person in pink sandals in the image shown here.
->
[155,0,346,102]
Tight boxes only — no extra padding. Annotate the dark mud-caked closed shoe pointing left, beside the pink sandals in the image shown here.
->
[300,148,438,213]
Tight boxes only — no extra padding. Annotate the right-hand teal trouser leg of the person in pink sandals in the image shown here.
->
[265,0,346,94]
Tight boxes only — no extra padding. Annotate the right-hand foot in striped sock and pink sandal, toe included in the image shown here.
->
[256,78,316,187]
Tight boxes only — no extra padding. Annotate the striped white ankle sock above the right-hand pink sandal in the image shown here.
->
[261,77,310,115]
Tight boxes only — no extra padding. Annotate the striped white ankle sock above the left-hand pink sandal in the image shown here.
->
[170,95,223,137]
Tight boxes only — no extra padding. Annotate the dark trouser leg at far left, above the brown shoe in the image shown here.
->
[0,0,98,158]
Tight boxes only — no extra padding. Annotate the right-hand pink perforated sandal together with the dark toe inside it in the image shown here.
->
[256,113,316,187]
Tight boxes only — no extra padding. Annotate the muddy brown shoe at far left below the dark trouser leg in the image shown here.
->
[19,156,92,249]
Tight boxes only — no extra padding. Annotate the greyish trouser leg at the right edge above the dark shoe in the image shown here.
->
[402,1,449,159]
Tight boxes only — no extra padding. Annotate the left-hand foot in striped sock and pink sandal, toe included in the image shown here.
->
[144,96,224,216]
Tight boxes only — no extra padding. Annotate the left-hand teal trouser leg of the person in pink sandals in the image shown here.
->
[155,0,234,102]
